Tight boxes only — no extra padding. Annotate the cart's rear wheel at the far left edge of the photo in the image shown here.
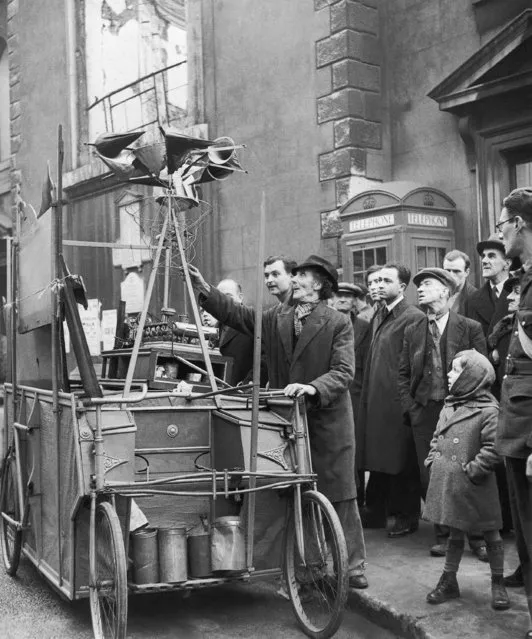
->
[0,454,22,575]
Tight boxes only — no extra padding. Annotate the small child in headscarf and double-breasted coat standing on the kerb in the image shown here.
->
[423,350,510,610]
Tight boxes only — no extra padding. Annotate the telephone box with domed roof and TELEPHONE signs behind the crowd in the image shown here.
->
[340,182,456,303]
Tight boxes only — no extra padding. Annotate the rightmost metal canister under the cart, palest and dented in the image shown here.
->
[211,516,246,572]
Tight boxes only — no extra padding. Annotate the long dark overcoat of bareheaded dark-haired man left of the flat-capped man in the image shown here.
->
[360,299,426,475]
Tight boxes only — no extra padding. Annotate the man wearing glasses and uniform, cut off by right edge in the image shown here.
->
[496,187,532,639]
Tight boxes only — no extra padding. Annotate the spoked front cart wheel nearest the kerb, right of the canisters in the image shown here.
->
[284,490,349,639]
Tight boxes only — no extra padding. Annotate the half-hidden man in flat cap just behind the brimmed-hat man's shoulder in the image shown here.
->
[332,282,371,506]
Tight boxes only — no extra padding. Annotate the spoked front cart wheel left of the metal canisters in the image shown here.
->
[90,501,127,639]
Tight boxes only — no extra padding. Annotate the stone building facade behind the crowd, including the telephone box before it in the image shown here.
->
[0,0,532,312]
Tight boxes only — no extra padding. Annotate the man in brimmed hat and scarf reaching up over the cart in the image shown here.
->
[189,255,368,588]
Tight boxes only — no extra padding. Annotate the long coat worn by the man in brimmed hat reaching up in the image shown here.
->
[200,288,356,502]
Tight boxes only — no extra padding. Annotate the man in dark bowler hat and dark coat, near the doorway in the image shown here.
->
[466,233,512,338]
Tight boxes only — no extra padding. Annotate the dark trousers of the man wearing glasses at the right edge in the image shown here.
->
[505,457,532,618]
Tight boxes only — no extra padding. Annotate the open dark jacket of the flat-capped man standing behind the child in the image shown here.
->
[398,311,488,413]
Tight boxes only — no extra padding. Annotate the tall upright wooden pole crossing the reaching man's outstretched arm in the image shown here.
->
[246,191,266,571]
